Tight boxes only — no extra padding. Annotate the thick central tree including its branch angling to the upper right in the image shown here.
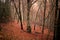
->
[27,0,37,33]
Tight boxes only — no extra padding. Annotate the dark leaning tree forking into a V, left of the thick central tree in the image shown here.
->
[11,0,23,30]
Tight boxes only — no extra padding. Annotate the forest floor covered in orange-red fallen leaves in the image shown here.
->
[0,21,53,40]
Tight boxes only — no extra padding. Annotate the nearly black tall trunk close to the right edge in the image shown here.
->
[53,0,59,40]
